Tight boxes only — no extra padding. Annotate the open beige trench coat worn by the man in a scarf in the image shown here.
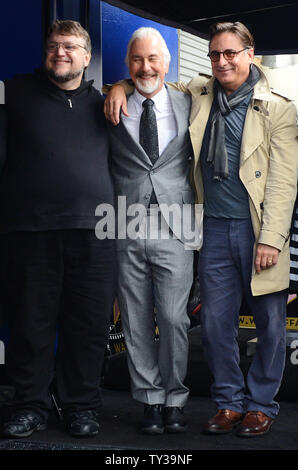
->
[170,69,298,295]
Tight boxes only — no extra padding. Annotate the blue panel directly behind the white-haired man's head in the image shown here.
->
[102,2,178,83]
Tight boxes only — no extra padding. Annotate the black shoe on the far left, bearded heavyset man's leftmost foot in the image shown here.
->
[2,410,47,437]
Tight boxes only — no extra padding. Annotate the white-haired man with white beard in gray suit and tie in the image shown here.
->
[109,28,199,434]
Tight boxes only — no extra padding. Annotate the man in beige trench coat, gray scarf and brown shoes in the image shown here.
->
[105,22,298,437]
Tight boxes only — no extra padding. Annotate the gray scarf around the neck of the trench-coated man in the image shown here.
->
[207,64,260,181]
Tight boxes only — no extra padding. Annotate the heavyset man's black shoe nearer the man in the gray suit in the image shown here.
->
[65,410,99,437]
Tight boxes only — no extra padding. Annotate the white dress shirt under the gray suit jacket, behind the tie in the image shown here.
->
[122,86,177,155]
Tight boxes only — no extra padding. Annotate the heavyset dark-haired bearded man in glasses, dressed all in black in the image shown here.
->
[0,21,116,437]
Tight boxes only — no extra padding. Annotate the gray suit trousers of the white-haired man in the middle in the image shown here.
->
[117,209,193,406]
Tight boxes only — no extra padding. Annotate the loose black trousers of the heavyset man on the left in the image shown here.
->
[0,229,116,415]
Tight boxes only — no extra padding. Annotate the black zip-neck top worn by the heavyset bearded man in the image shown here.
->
[0,71,114,233]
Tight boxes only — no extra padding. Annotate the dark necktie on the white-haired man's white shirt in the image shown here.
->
[140,99,159,164]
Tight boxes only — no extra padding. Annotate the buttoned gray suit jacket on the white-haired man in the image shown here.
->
[108,88,197,249]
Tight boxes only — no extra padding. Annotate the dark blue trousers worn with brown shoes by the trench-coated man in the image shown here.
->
[199,217,288,418]
